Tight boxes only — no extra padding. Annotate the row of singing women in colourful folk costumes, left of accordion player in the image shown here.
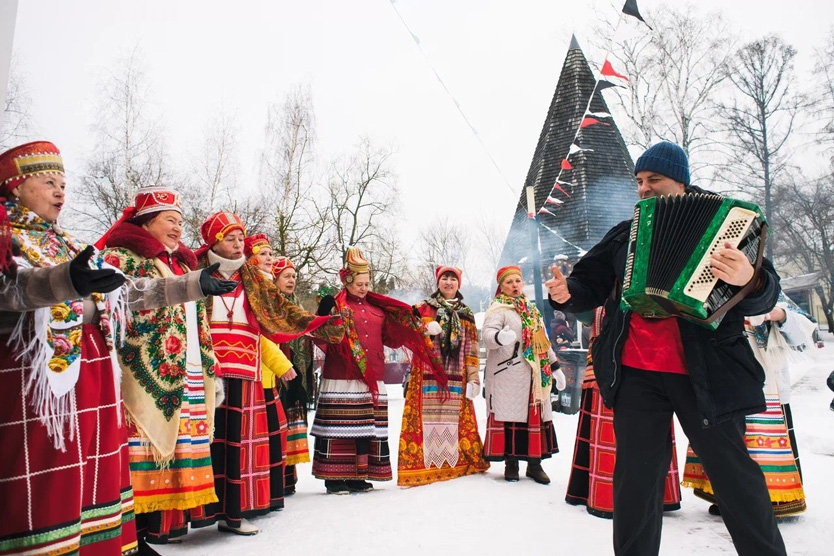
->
[0,142,592,554]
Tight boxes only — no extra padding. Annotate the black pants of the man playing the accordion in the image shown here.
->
[614,367,786,556]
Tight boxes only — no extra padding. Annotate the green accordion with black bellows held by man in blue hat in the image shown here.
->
[621,193,767,329]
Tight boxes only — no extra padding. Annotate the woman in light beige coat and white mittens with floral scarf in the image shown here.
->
[482,266,565,485]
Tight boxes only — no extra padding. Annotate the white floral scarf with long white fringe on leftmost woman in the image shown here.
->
[6,203,124,448]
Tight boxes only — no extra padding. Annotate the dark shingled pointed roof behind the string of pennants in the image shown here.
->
[501,37,637,268]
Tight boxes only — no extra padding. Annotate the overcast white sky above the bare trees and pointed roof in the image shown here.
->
[6,0,834,282]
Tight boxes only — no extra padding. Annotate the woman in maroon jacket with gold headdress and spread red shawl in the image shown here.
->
[310,247,448,494]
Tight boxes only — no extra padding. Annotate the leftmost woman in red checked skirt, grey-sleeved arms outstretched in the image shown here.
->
[0,141,232,554]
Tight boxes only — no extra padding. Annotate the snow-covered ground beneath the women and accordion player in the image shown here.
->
[155,334,834,556]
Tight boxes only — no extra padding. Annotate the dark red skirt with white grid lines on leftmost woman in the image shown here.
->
[0,325,138,556]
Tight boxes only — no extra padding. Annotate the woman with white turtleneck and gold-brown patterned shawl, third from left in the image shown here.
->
[192,212,344,535]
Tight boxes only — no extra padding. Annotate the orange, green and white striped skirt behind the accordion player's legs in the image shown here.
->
[683,395,807,517]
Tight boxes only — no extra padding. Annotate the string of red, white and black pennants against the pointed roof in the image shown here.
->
[527,0,651,217]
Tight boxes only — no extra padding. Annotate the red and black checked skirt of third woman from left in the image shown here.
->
[191,378,284,527]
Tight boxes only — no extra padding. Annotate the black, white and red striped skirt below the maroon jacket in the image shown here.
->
[310,379,393,481]
